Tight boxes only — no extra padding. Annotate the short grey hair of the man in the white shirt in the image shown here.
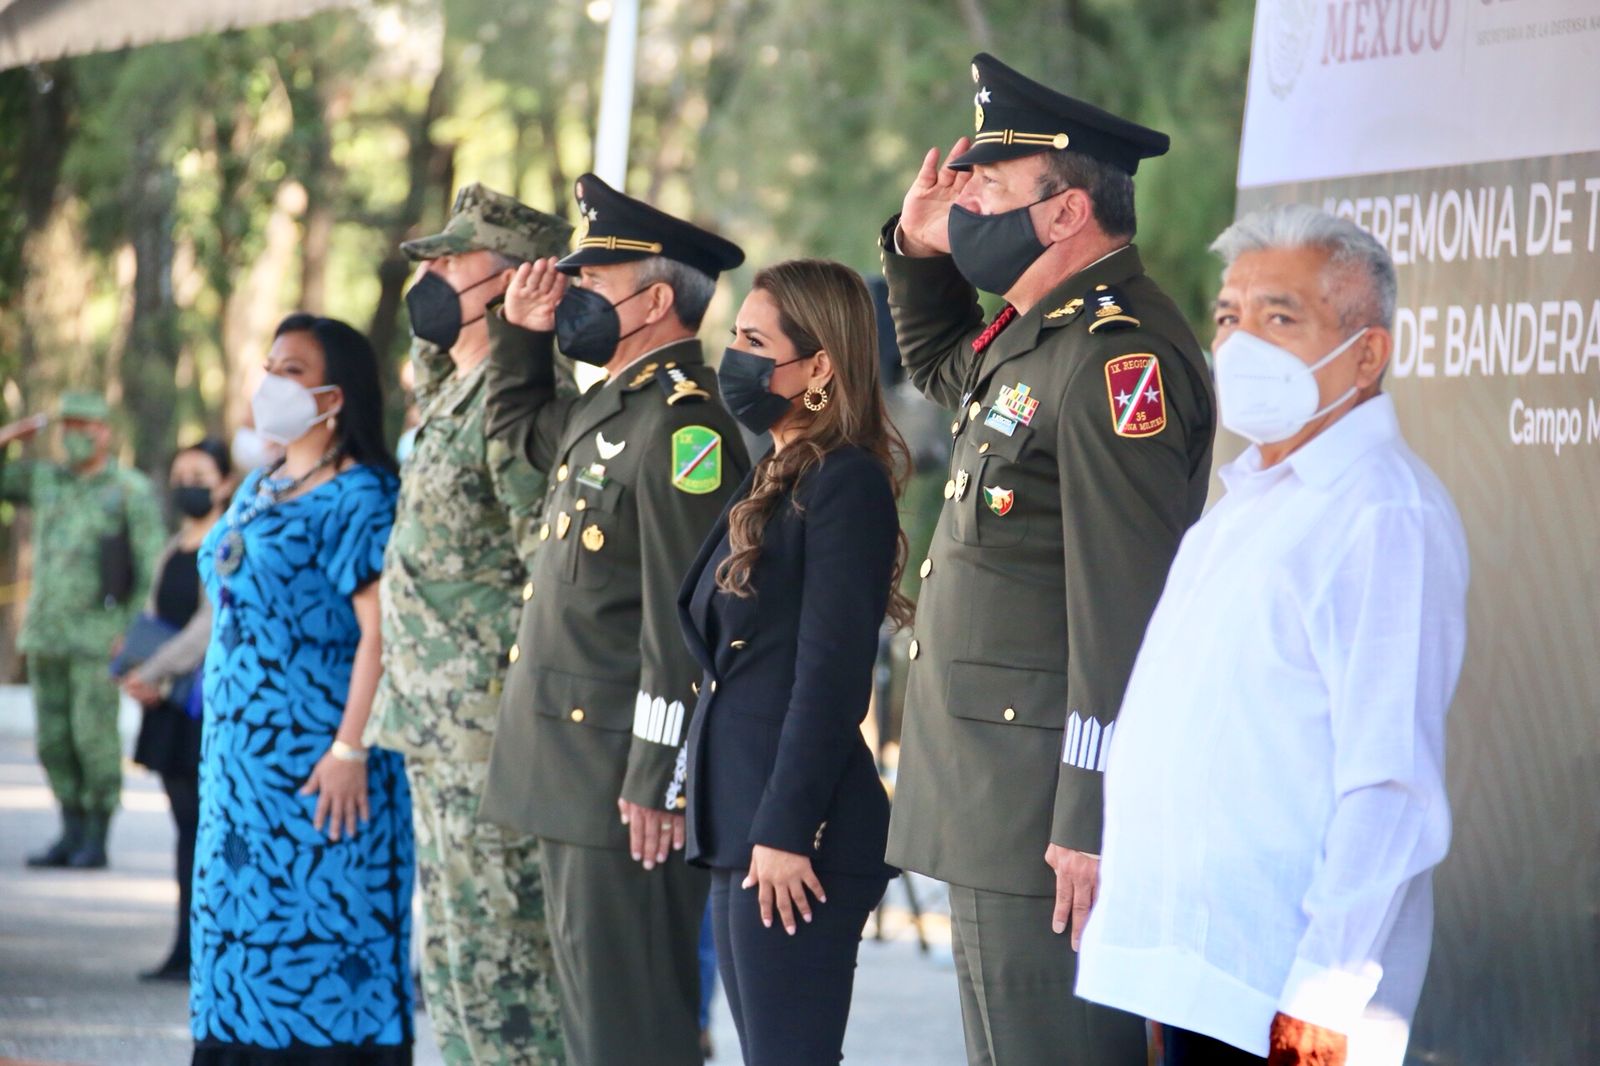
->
[1211,203,1400,330]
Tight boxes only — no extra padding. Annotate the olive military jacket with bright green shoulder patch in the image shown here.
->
[480,315,749,848]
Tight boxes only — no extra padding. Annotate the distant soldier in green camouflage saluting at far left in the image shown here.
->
[0,392,166,868]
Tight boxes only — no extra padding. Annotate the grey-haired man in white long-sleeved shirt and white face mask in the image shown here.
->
[1077,206,1467,1066]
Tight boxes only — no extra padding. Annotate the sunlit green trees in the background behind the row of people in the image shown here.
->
[0,0,1251,466]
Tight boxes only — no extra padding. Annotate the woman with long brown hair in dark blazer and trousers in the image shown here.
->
[678,259,910,1066]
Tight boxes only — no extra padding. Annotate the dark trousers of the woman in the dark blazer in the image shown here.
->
[710,869,888,1066]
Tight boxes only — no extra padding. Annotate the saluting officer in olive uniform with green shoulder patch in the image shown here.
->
[482,174,749,1066]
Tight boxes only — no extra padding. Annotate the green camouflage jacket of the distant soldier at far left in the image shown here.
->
[0,459,166,659]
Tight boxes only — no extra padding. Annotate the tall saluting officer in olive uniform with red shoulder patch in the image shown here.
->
[883,54,1213,1066]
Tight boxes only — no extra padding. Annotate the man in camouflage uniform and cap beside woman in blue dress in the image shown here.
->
[365,184,571,1066]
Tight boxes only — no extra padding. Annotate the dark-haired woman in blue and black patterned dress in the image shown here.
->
[190,315,413,1066]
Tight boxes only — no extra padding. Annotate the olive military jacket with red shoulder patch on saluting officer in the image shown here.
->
[883,219,1214,895]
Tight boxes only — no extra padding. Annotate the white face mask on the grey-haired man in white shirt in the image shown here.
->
[1216,327,1366,445]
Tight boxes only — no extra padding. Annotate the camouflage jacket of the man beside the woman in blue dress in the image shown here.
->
[366,341,544,760]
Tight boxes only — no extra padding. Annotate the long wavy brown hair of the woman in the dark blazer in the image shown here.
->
[717,259,914,626]
